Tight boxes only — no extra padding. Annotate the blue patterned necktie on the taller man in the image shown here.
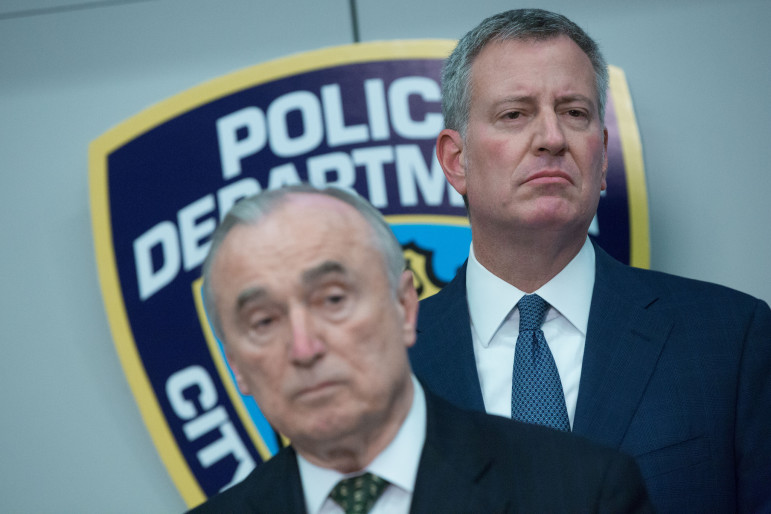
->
[511,294,570,432]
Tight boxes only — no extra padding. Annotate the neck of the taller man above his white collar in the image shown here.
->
[472,225,586,293]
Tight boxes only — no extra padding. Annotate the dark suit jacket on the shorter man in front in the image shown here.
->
[188,391,652,514]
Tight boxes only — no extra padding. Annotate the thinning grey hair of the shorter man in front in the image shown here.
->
[203,184,406,342]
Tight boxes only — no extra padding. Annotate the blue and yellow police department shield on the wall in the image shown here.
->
[90,40,648,506]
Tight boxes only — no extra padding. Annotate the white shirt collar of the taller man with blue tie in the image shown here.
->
[466,237,595,347]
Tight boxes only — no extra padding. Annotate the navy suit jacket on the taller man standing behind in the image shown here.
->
[410,241,771,513]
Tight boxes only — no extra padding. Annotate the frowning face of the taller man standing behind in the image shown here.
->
[440,37,607,233]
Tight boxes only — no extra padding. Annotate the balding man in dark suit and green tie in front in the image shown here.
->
[191,186,651,514]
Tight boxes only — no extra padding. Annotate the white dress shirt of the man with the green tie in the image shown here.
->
[297,376,426,514]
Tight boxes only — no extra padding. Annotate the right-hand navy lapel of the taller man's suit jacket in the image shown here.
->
[573,245,672,447]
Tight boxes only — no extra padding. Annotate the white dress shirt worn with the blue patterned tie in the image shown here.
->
[466,237,595,427]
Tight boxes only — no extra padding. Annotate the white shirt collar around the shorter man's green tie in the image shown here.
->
[297,375,426,513]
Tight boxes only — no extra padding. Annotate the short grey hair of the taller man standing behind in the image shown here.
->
[442,9,608,138]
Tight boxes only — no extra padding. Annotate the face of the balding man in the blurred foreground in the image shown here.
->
[211,194,417,453]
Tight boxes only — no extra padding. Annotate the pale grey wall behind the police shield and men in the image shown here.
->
[0,0,771,513]
